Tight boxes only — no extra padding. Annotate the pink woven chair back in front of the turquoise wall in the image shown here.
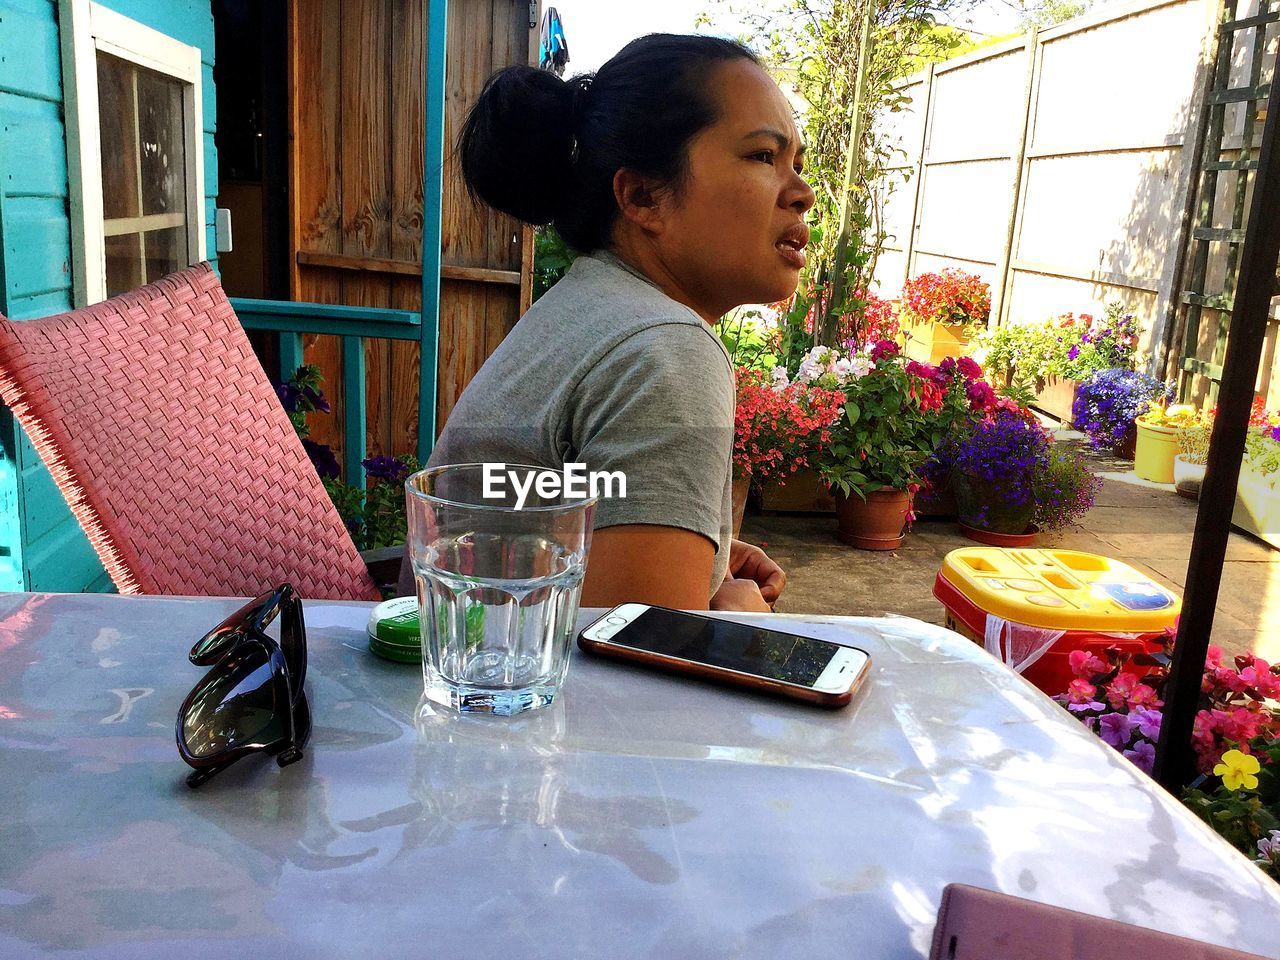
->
[0,264,379,599]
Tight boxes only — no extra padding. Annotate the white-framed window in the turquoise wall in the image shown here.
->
[60,0,205,303]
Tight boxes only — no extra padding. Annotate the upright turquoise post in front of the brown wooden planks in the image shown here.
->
[417,0,449,465]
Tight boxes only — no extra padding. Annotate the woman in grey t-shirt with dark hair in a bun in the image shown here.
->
[404,33,814,611]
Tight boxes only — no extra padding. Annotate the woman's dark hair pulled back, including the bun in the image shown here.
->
[458,33,759,251]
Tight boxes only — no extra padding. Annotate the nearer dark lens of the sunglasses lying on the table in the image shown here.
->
[182,644,291,759]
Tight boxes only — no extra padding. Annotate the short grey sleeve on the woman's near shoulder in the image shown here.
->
[570,321,733,552]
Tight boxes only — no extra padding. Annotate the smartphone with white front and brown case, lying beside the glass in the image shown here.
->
[577,603,872,708]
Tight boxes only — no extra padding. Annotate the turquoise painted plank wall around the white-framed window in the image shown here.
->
[0,0,218,591]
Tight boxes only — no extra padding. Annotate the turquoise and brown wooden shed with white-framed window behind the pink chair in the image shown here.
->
[0,0,540,591]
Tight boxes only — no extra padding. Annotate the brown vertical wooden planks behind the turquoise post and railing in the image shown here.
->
[289,0,536,471]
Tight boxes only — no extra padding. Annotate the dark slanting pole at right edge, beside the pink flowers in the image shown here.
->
[1155,71,1280,794]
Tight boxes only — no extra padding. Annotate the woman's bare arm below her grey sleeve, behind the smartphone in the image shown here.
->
[581,524,769,612]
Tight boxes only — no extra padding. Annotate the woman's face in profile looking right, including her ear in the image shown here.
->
[654,60,814,316]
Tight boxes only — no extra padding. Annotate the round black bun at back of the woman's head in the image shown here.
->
[458,67,586,224]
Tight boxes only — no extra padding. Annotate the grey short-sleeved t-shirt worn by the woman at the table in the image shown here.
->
[414,250,735,596]
